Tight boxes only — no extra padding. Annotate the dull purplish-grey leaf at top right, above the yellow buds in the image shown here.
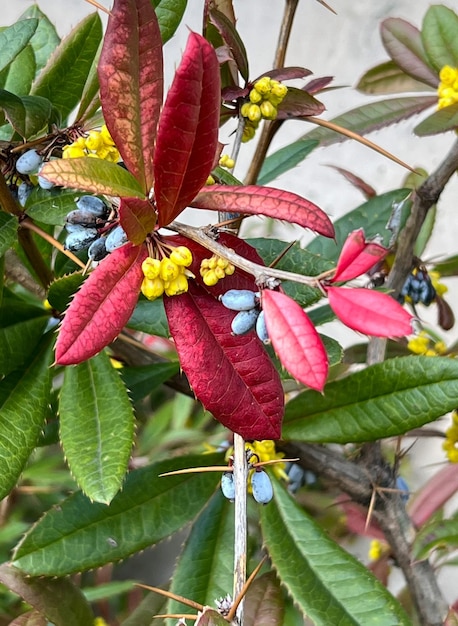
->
[380,17,439,89]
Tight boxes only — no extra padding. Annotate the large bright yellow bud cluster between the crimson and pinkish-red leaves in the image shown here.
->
[141,246,194,300]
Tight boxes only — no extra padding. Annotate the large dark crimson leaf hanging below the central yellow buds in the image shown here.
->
[164,285,284,439]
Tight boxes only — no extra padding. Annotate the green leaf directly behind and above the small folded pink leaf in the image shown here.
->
[307,189,411,262]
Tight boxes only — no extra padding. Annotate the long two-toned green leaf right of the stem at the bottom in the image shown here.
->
[261,479,411,626]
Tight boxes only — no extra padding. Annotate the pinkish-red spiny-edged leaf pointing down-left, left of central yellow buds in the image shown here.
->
[56,244,148,365]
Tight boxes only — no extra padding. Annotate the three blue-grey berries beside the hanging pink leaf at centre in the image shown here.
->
[220,289,269,344]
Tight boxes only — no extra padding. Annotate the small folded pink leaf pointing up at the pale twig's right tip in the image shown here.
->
[332,228,388,282]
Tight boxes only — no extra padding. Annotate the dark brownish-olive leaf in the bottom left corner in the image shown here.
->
[0,563,94,626]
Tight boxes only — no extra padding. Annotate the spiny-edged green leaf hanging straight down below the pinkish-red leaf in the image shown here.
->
[59,352,134,504]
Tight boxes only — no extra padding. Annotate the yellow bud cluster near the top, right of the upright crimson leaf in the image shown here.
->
[240,76,288,142]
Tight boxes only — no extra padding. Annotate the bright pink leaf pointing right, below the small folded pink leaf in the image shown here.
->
[326,287,414,337]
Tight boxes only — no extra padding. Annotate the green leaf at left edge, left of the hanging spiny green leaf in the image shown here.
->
[0,333,53,498]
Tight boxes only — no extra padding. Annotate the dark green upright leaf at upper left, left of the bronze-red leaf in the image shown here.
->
[31,13,102,119]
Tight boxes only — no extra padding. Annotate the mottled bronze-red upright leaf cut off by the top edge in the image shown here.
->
[98,0,163,193]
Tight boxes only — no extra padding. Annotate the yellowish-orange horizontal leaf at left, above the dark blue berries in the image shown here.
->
[40,157,145,198]
